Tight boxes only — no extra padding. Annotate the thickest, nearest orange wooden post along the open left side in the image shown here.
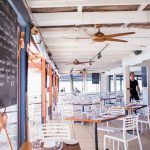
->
[41,58,46,123]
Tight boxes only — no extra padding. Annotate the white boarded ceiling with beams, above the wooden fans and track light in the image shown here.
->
[28,0,150,73]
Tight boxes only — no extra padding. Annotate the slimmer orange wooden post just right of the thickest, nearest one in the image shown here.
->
[49,66,53,119]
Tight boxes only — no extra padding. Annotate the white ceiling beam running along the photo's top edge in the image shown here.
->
[28,0,150,8]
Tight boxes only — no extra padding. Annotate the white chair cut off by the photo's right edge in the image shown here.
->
[138,106,150,133]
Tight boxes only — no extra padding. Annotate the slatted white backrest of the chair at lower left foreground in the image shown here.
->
[41,123,70,140]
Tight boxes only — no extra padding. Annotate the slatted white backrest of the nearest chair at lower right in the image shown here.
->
[123,114,138,133]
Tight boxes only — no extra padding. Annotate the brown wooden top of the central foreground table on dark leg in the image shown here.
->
[64,115,126,123]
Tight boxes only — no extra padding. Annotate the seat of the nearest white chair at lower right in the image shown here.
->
[105,132,137,142]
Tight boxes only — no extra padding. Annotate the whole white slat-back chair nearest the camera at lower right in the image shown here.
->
[104,115,143,150]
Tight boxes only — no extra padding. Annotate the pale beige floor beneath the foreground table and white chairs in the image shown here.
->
[73,123,150,150]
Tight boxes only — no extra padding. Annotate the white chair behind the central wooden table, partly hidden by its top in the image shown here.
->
[97,107,125,133]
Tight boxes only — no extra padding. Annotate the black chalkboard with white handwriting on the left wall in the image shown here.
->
[0,0,18,108]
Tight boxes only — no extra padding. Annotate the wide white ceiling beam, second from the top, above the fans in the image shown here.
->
[33,11,150,26]
